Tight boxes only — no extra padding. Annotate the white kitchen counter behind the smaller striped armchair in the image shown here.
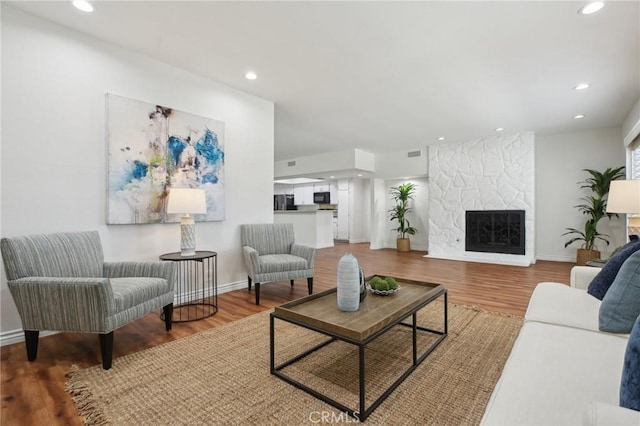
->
[273,210,333,249]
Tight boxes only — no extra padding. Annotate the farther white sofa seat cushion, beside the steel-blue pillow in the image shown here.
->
[524,283,601,331]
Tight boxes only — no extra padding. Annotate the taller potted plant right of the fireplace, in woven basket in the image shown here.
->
[562,166,624,265]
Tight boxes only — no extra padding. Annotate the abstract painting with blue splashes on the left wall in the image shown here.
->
[107,94,225,224]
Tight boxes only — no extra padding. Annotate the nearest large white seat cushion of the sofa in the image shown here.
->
[481,321,627,426]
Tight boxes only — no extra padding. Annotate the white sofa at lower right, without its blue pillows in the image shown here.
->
[481,266,640,426]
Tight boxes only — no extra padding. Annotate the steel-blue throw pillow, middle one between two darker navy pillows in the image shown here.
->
[598,251,640,333]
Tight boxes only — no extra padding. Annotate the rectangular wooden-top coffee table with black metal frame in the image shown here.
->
[269,277,447,421]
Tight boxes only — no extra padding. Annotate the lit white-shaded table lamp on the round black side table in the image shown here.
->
[167,188,207,256]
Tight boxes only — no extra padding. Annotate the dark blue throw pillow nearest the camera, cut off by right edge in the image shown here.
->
[620,316,640,411]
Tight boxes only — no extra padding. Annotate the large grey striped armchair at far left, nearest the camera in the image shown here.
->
[0,231,174,370]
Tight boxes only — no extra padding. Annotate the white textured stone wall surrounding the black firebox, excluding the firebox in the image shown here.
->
[429,132,536,266]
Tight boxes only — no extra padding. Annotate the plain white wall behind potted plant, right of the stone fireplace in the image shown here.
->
[536,128,626,262]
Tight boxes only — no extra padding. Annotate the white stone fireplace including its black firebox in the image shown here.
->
[428,132,536,266]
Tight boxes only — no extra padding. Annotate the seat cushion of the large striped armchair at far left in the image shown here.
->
[110,277,171,312]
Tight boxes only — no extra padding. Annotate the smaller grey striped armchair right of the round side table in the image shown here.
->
[240,223,316,305]
